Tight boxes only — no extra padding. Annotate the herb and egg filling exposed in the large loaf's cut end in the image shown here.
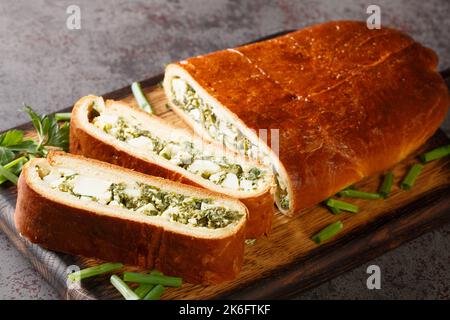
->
[171,78,290,210]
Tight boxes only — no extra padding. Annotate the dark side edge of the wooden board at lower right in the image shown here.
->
[213,185,450,300]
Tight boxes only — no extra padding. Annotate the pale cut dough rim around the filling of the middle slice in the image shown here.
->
[71,95,274,200]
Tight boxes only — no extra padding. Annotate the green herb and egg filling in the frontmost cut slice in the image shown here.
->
[36,167,244,229]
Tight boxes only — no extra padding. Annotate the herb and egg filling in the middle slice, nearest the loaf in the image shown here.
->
[91,105,270,191]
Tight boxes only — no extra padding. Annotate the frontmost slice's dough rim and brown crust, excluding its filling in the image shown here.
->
[15,153,247,284]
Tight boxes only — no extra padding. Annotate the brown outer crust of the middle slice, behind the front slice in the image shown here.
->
[70,97,275,239]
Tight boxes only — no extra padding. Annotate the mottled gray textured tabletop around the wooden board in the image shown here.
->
[0,0,450,299]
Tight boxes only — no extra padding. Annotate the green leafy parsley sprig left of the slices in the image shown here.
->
[0,106,69,184]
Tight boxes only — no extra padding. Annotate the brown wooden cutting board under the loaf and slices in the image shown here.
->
[0,31,450,299]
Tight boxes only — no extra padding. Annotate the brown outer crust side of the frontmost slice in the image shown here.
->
[14,154,245,284]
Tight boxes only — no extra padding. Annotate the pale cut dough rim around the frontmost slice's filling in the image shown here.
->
[23,152,247,238]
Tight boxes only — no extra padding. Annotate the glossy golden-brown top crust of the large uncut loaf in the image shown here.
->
[166,21,449,212]
